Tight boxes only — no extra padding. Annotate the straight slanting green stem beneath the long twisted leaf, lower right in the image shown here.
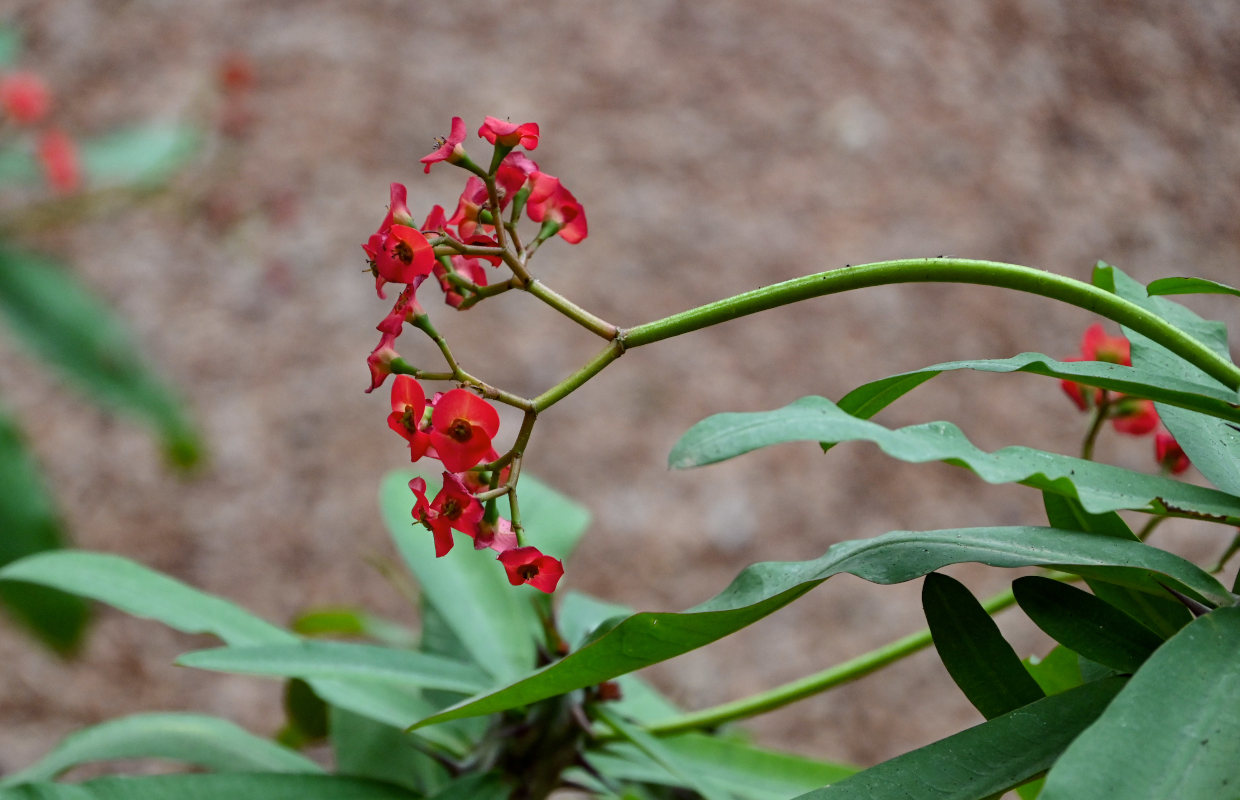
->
[629,589,1016,738]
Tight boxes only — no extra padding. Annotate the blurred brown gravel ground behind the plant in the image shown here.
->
[0,0,1240,783]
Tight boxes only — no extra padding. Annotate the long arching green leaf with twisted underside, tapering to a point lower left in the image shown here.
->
[418,527,1231,726]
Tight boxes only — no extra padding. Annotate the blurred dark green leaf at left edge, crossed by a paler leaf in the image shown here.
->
[0,401,89,655]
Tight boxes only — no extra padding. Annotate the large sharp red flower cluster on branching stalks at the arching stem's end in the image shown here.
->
[362,117,575,592]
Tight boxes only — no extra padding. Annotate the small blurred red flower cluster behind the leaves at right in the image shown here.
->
[1060,322,1189,474]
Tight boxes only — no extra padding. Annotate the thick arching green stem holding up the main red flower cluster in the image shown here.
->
[620,258,1240,389]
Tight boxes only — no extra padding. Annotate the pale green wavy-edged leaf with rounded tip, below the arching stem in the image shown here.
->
[670,397,1240,525]
